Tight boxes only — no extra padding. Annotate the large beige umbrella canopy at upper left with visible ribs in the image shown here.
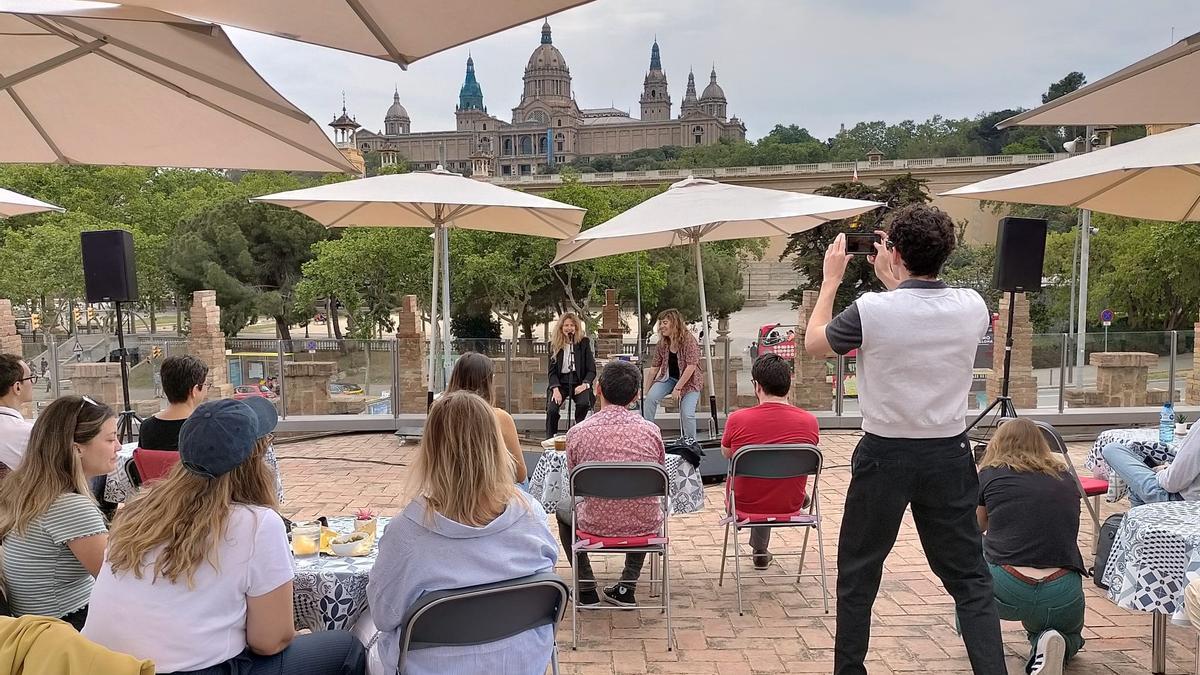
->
[0,2,354,172]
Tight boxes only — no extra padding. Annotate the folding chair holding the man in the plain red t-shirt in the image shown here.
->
[716,443,829,616]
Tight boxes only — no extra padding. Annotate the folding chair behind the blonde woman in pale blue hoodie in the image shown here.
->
[397,572,569,675]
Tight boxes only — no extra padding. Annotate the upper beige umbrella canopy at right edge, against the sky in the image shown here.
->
[997,32,1200,129]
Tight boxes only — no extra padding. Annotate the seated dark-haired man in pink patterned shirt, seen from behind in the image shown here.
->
[557,360,666,608]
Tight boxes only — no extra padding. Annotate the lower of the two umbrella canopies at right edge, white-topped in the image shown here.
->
[942,125,1200,221]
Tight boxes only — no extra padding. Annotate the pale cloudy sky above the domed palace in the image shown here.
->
[230,0,1200,138]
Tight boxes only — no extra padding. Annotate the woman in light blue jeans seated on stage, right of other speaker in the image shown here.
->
[642,310,703,438]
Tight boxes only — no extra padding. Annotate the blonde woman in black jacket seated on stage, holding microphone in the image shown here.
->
[546,312,596,438]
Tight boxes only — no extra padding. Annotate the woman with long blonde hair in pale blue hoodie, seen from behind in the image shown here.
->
[367,390,558,675]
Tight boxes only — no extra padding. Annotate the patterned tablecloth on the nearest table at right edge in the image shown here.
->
[1103,502,1200,620]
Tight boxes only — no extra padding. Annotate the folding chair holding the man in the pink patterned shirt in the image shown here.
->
[570,461,674,651]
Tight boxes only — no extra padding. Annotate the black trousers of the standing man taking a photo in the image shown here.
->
[834,434,1007,675]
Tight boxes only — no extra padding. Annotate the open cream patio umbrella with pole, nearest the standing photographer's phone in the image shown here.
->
[553,177,883,424]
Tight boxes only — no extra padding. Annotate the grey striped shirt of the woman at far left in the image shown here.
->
[2,492,107,619]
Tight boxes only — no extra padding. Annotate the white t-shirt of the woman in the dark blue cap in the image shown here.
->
[83,506,294,673]
